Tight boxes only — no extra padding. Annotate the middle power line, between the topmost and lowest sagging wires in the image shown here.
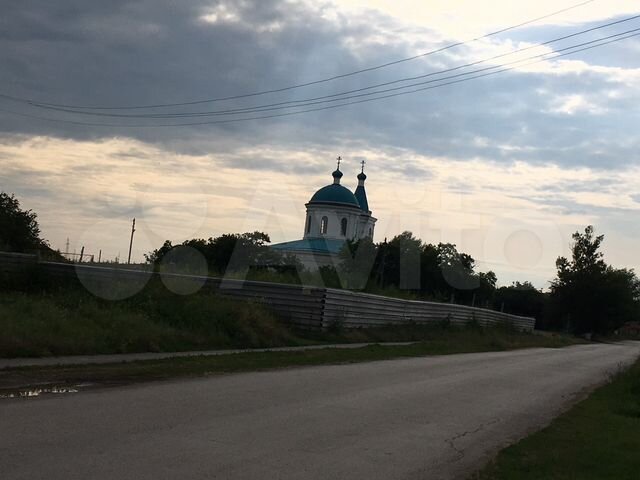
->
[31,15,640,119]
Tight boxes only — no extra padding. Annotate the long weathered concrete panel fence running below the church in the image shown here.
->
[0,252,535,331]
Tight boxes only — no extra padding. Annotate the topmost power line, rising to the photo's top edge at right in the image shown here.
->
[0,0,596,110]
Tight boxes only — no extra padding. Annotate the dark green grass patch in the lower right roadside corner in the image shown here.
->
[472,361,640,480]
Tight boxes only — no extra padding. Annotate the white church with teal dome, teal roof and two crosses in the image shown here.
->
[272,157,376,270]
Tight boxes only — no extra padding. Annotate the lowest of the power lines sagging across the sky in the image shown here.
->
[0,28,640,128]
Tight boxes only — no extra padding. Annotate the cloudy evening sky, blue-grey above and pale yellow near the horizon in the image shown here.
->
[0,0,640,288]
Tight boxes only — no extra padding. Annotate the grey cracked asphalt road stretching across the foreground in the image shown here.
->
[0,343,640,480]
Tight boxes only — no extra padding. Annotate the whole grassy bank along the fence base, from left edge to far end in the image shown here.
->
[0,282,571,357]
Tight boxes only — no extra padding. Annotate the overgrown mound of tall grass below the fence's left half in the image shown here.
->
[0,282,301,357]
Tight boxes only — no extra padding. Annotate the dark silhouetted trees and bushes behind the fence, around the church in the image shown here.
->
[0,192,640,334]
